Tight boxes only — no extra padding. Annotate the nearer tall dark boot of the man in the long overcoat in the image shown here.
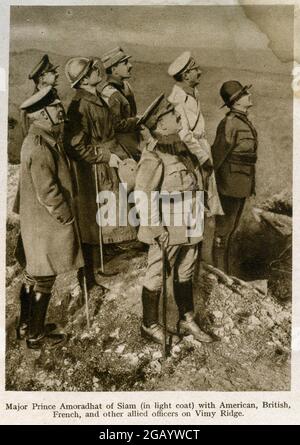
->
[26,292,66,349]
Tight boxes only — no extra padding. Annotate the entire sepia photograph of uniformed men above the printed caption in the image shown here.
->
[3,2,295,398]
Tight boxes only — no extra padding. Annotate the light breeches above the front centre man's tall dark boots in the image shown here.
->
[144,244,199,291]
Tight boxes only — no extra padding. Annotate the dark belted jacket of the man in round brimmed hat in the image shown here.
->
[212,109,258,198]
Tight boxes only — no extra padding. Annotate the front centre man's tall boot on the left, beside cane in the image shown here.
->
[141,287,164,344]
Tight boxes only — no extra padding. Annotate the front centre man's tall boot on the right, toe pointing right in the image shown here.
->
[174,280,213,343]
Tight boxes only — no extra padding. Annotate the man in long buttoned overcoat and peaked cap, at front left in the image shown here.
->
[17,86,83,349]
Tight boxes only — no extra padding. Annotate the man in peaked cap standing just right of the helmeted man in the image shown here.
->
[101,47,140,160]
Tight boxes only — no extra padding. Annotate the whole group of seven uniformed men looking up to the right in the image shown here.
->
[17,47,257,349]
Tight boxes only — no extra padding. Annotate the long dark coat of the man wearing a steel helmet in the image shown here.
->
[64,89,136,245]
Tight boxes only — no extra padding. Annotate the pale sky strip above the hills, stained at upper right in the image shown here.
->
[11,6,291,60]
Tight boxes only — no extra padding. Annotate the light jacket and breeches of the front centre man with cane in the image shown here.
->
[135,141,202,291]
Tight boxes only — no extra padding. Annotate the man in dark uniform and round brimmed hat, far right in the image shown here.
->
[212,80,258,273]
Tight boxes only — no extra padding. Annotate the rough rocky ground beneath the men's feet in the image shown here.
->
[6,167,291,391]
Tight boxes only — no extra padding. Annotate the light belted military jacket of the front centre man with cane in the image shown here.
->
[135,140,204,246]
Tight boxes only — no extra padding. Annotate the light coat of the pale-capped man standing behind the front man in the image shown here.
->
[168,84,224,216]
